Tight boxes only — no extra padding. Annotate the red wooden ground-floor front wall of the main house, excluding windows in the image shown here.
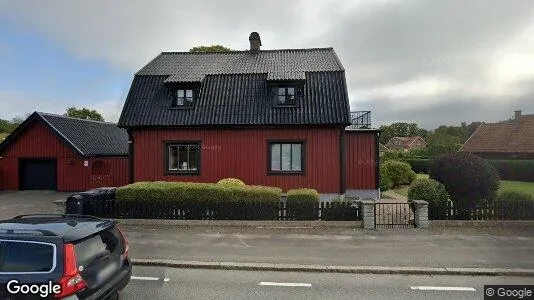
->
[133,127,340,193]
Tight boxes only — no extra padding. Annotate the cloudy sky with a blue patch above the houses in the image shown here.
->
[0,0,534,128]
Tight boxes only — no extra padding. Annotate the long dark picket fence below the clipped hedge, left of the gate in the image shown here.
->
[72,199,362,221]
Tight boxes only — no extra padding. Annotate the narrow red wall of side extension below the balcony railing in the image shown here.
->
[345,131,378,190]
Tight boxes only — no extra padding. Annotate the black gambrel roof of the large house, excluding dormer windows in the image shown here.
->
[118,48,350,127]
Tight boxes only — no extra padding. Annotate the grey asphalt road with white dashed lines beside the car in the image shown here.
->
[122,267,534,300]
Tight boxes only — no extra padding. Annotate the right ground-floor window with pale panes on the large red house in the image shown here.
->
[269,142,304,173]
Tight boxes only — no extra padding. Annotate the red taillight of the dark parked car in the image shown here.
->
[55,244,87,298]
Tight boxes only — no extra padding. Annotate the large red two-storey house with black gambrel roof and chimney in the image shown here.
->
[118,33,378,198]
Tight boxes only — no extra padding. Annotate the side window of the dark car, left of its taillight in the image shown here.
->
[0,240,55,273]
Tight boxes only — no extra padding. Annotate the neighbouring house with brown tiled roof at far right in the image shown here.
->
[460,110,534,159]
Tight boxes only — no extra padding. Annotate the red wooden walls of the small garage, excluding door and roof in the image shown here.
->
[0,121,128,191]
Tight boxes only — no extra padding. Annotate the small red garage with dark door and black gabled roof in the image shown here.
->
[0,112,128,191]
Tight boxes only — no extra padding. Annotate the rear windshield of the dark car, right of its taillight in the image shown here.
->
[74,228,120,267]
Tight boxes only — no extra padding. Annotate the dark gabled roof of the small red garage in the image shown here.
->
[0,112,128,157]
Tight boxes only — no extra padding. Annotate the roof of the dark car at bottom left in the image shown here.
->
[0,215,116,242]
